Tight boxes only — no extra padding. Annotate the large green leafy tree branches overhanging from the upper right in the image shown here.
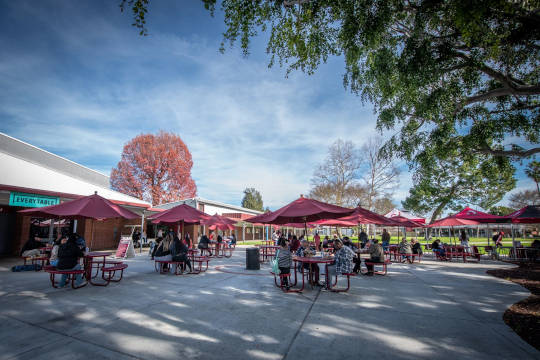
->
[121,0,540,166]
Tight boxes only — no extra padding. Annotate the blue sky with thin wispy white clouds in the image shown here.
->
[0,0,533,209]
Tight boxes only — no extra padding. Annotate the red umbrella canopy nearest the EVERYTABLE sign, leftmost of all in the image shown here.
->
[19,193,140,219]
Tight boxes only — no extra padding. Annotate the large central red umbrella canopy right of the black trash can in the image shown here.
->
[246,197,354,224]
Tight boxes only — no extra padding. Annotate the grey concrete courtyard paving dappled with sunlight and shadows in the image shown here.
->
[0,247,540,360]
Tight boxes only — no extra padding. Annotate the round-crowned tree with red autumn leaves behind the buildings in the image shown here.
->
[111,131,197,205]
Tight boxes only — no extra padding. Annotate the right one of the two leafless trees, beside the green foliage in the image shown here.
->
[361,137,399,210]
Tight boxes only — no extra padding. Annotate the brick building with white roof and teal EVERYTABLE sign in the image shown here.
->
[0,133,151,255]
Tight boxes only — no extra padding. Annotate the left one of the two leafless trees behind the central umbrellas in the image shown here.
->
[310,139,361,206]
